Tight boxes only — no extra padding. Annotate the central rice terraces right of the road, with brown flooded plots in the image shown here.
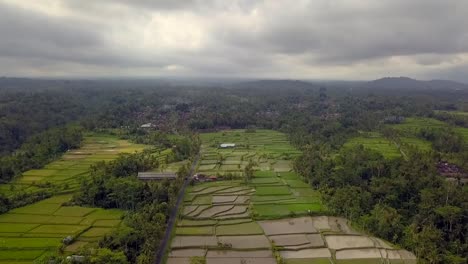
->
[166,130,416,264]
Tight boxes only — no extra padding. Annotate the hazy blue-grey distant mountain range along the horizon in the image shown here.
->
[0,77,468,92]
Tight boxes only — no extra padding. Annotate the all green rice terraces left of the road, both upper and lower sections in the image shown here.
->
[0,135,150,263]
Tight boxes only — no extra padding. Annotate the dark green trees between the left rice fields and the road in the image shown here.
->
[38,131,199,264]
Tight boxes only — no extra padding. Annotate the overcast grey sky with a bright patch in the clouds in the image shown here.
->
[0,0,468,82]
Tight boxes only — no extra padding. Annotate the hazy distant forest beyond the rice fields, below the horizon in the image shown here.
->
[0,78,468,155]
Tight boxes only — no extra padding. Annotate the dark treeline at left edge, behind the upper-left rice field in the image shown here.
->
[0,125,83,183]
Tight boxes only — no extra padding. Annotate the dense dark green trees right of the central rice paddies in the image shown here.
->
[294,145,468,264]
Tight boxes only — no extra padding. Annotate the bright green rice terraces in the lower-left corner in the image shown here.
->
[0,195,123,264]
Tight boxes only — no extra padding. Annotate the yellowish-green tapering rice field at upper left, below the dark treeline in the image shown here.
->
[0,135,145,195]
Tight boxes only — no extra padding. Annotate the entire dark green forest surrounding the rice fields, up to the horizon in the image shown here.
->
[0,81,468,263]
